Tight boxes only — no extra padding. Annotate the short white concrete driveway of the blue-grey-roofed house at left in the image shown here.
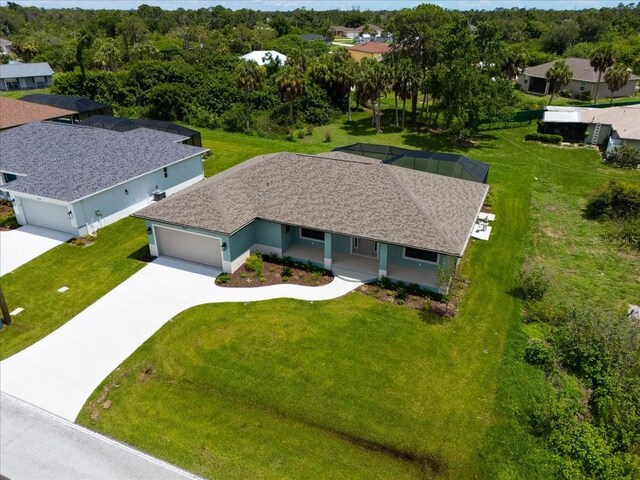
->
[0,225,71,276]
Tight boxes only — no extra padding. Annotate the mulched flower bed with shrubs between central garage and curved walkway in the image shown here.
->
[216,260,333,288]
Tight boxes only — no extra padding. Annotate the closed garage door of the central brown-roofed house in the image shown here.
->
[154,227,222,268]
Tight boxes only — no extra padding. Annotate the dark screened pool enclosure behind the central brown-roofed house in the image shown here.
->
[333,143,489,183]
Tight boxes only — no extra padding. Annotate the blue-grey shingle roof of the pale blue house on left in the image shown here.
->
[0,122,206,202]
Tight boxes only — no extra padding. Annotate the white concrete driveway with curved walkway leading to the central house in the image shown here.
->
[0,257,363,421]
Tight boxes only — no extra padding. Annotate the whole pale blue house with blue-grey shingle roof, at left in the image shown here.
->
[0,122,206,236]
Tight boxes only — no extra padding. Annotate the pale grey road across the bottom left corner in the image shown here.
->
[0,394,200,480]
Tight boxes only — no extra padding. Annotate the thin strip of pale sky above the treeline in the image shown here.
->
[0,0,630,11]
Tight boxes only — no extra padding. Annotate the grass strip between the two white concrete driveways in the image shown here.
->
[0,218,147,359]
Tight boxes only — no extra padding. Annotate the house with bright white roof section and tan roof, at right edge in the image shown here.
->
[540,105,640,153]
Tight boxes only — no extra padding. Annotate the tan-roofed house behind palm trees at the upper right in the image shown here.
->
[518,57,639,98]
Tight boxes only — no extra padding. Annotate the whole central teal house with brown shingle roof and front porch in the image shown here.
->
[134,152,488,291]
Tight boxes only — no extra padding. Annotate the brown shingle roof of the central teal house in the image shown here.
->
[136,152,488,255]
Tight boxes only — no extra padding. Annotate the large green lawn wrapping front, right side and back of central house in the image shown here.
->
[79,119,640,478]
